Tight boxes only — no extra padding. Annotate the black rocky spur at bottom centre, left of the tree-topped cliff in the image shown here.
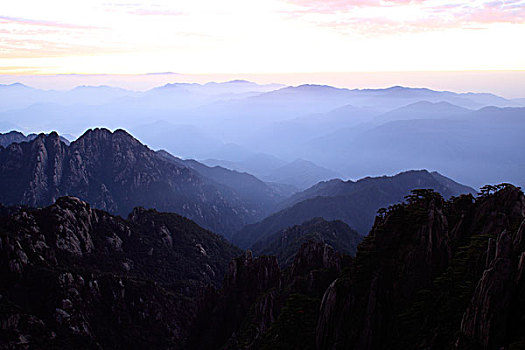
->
[189,241,346,349]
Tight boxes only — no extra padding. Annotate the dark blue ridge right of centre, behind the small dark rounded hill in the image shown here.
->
[232,170,474,247]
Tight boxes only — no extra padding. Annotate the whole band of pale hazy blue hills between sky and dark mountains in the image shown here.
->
[0,81,525,187]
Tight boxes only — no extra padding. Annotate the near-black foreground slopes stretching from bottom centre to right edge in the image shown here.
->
[189,184,525,350]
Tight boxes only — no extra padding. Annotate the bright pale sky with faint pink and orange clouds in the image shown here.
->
[0,0,525,95]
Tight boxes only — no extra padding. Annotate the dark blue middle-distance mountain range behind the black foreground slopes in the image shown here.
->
[0,129,475,248]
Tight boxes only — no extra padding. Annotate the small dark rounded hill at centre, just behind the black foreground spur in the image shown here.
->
[251,218,363,268]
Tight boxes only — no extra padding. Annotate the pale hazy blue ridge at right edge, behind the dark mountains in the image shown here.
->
[305,106,525,186]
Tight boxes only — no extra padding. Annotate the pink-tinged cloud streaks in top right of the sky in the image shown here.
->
[286,0,525,35]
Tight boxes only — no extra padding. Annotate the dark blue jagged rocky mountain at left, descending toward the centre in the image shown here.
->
[0,129,260,235]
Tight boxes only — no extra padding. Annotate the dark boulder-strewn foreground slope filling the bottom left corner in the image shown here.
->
[0,197,239,349]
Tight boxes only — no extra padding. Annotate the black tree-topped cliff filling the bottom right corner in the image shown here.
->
[316,186,525,349]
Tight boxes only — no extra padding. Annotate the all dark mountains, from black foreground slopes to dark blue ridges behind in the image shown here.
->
[0,121,525,350]
